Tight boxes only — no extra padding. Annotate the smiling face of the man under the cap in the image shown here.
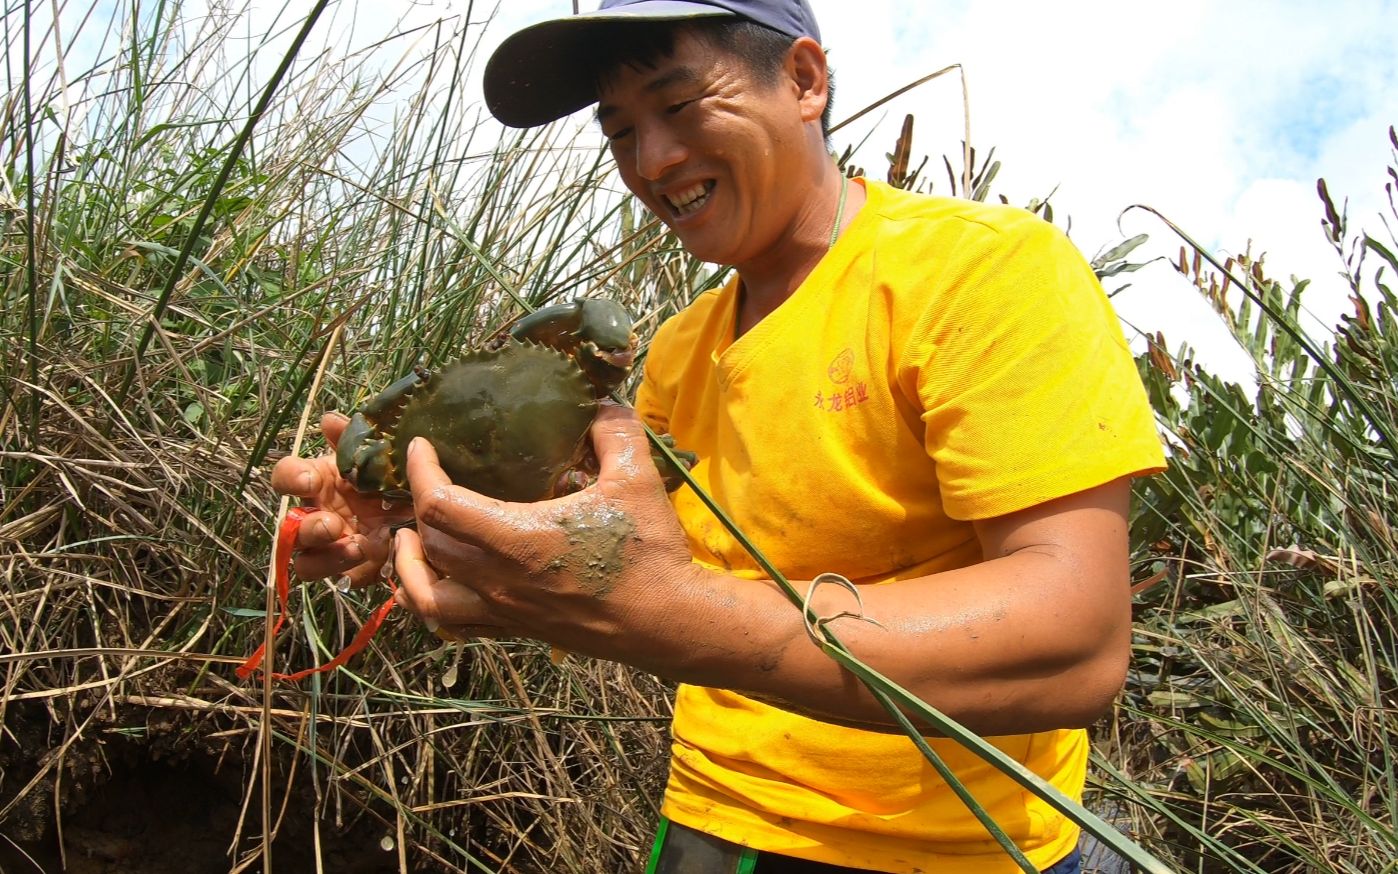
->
[597,31,808,268]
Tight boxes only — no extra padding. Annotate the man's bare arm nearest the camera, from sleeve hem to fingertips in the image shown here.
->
[396,408,1131,734]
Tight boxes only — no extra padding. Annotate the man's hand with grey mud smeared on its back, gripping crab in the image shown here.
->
[394,404,699,664]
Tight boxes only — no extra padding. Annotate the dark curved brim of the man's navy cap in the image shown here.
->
[484,0,735,127]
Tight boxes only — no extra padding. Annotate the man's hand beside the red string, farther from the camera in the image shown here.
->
[271,413,412,586]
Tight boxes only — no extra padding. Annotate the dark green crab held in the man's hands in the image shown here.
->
[336,298,693,502]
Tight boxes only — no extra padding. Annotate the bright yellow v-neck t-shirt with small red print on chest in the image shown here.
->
[636,182,1165,874]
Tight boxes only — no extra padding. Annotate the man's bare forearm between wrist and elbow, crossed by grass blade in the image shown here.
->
[628,551,1130,734]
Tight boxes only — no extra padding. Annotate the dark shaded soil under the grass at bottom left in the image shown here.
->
[0,705,424,874]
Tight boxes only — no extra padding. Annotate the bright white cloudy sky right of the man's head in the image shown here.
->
[794,0,1398,376]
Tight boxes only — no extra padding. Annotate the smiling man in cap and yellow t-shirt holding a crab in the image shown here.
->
[274,0,1163,874]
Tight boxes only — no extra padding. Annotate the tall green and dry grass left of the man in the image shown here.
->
[0,0,710,871]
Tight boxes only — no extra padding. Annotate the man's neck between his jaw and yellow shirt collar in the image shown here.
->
[735,162,864,337]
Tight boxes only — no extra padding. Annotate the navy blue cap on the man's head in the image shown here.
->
[485,0,821,127]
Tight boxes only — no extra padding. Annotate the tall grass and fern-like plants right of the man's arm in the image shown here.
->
[1102,129,1398,874]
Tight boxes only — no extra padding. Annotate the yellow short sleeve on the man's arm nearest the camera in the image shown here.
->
[909,214,1165,519]
